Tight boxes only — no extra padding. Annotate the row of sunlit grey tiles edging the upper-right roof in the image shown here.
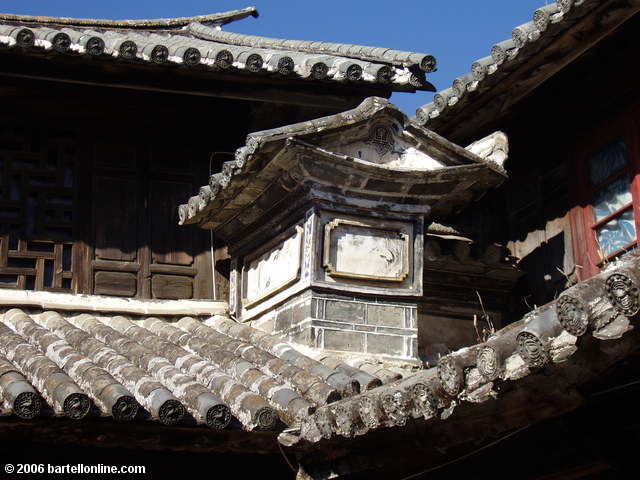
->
[413,0,600,125]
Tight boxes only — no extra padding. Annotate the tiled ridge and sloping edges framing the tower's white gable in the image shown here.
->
[178,97,507,231]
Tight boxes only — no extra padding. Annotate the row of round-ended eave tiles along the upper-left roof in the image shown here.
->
[0,22,435,92]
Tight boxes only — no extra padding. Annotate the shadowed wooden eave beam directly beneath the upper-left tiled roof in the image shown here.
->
[0,52,392,110]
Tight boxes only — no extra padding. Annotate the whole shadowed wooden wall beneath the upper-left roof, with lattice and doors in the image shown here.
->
[0,72,348,299]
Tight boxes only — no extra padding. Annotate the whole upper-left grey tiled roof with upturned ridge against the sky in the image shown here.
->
[0,8,435,91]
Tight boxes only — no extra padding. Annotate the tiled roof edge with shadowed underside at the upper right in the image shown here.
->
[413,0,639,132]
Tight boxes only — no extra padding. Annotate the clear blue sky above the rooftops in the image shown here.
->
[0,0,549,115]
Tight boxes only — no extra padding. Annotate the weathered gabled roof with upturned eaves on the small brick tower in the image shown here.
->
[179,98,506,231]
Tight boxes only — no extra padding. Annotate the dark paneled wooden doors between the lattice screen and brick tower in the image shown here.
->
[90,142,212,299]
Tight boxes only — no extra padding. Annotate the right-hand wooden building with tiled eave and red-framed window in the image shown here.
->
[417,2,640,318]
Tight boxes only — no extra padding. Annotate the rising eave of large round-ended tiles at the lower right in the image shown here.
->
[290,254,640,444]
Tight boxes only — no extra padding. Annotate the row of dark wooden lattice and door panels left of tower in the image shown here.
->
[0,122,213,299]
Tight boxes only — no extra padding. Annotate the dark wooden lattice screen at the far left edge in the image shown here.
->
[0,123,78,292]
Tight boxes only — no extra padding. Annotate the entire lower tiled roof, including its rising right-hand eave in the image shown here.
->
[0,249,640,445]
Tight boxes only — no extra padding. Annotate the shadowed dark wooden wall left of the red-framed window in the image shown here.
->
[442,16,640,319]
